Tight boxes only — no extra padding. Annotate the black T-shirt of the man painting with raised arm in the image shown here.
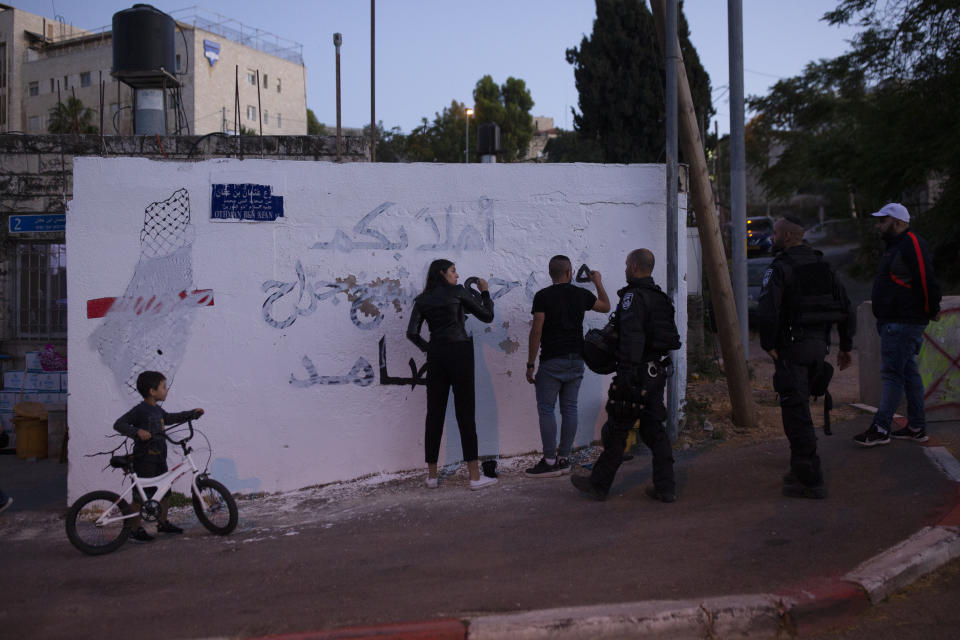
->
[533,282,597,362]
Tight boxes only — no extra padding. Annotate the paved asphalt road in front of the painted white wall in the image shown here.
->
[0,418,956,639]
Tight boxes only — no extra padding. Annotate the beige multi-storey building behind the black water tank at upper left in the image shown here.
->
[0,4,307,135]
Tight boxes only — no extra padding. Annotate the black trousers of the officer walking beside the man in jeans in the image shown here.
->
[590,375,676,494]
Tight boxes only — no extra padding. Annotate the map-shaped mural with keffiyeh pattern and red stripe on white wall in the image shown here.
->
[87,189,213,393]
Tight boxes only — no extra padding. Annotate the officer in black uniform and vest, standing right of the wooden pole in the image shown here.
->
[757,216,856,499]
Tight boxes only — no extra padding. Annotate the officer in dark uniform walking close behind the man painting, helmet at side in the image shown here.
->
[570,249,680,502]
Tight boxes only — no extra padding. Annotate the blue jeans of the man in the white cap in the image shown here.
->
[873,322,927,431]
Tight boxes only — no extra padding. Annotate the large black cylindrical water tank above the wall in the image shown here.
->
[113,4,177,78]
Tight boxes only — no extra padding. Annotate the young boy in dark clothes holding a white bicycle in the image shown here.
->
[113,371,203,542]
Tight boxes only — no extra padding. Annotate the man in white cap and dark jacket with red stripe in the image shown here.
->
[853,202,940,447]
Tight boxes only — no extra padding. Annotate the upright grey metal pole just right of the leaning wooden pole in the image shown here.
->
[727,0,750,359]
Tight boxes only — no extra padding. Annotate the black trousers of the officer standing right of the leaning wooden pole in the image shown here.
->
[773,339,827,486]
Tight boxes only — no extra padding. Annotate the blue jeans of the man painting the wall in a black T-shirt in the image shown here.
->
[535,355,583,458]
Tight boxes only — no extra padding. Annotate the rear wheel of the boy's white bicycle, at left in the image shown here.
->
[66,491,130,556]
